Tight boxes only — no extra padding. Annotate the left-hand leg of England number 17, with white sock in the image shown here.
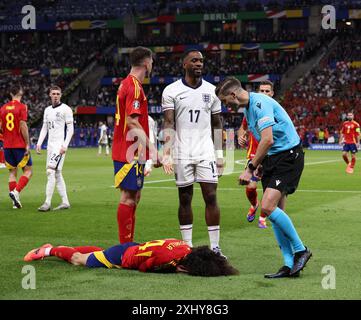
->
[178,185,193,247]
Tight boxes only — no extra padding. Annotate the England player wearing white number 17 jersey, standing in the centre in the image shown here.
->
[162,50,223,256]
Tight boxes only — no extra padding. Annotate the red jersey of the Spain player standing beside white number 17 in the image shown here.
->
[112,75,149,163]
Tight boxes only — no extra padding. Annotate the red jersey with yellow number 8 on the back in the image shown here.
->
[0,100,28,148]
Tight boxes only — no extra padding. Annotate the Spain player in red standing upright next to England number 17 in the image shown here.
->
[112,47,153,243]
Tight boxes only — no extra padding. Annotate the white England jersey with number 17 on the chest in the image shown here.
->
[162,79,221,160]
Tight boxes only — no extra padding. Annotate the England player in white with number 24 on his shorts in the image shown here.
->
[36,86,74,212]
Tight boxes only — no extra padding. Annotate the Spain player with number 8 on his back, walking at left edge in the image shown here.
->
[0,85,32,209]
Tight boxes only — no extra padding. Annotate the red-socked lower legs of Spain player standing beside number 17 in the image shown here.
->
[117,189,141,243]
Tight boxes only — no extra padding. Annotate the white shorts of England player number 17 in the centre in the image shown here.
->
[174,159,218,187]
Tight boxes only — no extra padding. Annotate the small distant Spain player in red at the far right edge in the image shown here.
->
[340,112,360,173]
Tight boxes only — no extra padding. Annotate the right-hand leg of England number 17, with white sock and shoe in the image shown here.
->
[199,182,225,257]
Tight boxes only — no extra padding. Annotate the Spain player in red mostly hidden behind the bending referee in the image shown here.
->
[238,80,274,229]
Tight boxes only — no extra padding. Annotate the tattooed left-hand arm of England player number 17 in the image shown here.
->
[162,109,175,174]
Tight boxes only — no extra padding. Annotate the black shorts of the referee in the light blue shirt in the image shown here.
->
[261,143,305,195]
